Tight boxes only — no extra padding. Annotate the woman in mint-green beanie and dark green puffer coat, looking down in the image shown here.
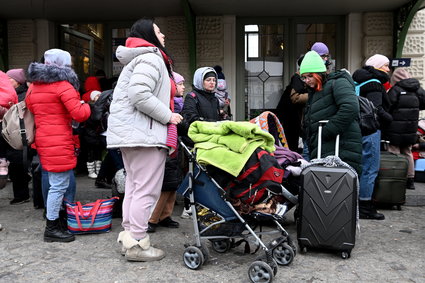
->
[300,51,362,175]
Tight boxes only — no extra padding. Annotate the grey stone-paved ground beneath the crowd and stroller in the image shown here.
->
[0,177,425,283]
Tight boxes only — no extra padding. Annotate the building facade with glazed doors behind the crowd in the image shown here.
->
[0,1,425,120]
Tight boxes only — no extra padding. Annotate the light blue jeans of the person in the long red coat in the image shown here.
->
[46,170,73,220]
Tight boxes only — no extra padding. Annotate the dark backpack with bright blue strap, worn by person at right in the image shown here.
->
[355,79,381,136]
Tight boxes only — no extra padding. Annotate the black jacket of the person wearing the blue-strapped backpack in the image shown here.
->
[353,66,393,128]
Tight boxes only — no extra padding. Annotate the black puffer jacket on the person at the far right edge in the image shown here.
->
[383,78,425,146]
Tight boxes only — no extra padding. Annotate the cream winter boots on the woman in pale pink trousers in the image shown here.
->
[121,233,165,261]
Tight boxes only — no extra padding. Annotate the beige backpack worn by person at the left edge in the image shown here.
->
[1,101,35,151]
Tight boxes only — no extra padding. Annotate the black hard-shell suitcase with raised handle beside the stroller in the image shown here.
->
[297,121,358,259]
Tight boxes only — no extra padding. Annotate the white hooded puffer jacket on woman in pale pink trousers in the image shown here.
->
[107,46,172,148]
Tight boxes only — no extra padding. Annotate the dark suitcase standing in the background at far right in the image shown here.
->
[372,151,409,210]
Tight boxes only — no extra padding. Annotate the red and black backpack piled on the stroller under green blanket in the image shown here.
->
[224,148,284,205]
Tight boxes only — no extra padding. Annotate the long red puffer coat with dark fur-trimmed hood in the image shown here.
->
[26,63,90,172]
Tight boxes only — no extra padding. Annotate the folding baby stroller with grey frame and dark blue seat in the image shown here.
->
[178,142,297,282]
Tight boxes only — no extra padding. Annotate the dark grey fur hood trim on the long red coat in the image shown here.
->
[28,63,80,91]
